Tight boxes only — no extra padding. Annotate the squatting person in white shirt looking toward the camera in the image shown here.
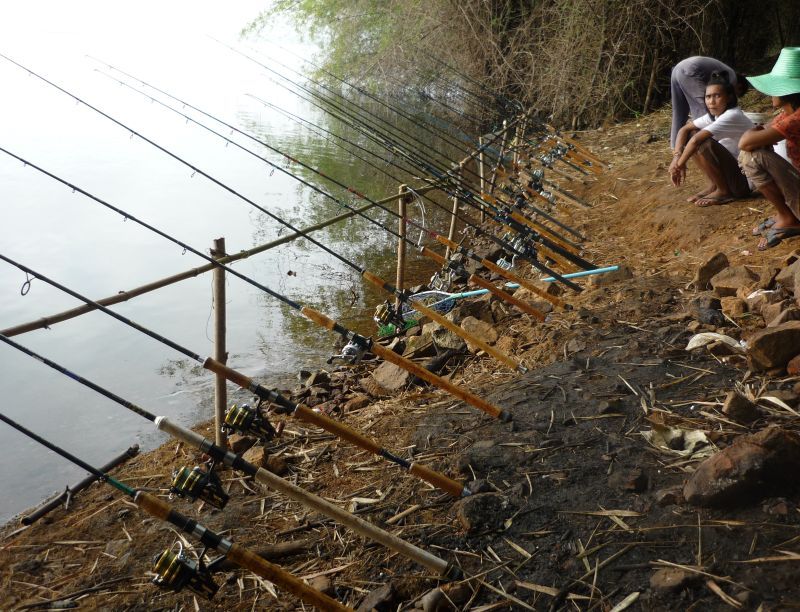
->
[669,72,753,206]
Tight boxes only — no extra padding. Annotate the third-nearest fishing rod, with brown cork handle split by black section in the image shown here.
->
[0,253,476,500]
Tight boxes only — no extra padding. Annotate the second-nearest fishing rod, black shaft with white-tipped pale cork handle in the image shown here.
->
[0,334,460,578]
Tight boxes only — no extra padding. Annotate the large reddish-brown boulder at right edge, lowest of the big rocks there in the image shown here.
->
[683,426,800,506]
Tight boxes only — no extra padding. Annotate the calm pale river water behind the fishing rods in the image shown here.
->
[0,0,456,521]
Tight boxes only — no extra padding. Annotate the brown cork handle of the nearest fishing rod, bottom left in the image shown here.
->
[133,491,352,612]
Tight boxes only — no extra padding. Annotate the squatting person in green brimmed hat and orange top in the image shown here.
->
[739,47,800,251]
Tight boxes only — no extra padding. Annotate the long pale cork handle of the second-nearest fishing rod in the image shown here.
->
[156,416,458,577]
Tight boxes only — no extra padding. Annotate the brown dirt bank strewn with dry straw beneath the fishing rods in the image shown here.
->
[0,105,800,612]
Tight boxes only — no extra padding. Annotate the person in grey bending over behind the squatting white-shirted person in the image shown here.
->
[670,55,738,149]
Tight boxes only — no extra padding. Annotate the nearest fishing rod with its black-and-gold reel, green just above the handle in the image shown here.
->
[0,413,353,612]
